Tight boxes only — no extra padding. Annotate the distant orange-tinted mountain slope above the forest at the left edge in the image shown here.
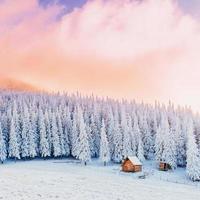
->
[0,77,39,91]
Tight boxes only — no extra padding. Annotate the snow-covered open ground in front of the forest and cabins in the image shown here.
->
[0,159,200,200]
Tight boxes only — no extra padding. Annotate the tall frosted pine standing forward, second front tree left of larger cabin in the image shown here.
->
[76,107,91,165]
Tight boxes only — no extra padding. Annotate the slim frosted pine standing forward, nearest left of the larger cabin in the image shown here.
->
[100,119,110,166]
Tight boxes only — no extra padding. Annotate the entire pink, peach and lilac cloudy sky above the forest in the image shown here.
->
[0,0,200,110]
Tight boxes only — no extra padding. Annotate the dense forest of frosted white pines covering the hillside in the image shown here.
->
[0,91,200,181]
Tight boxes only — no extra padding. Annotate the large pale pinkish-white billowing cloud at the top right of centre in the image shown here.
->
[59,0,196,60]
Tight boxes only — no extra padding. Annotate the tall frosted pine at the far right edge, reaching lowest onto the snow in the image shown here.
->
[186,118,200,181]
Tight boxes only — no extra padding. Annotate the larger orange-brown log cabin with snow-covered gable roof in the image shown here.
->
[122,156,142,172]
